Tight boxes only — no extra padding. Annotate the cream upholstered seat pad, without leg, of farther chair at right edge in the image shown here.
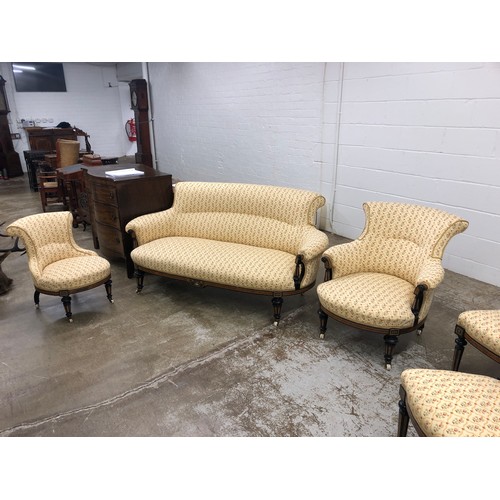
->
[457,309,500,355]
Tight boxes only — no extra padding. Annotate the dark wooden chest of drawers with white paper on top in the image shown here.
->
[82,164,174,278]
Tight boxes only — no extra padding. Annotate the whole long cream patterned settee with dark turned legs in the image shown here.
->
[126,182,328,325]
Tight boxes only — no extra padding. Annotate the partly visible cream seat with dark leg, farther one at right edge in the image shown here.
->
[452,309,500,370]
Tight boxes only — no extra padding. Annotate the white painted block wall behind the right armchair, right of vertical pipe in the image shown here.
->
[333,63,500,285]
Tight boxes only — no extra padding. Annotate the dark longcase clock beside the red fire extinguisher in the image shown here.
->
[129,79,153,167]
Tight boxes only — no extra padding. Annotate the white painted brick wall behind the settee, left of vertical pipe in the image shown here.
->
[150,63,324,191]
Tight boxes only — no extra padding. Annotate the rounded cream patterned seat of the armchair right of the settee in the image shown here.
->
[317,273,415,329]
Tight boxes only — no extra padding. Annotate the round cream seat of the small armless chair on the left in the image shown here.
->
[35,255,111,293]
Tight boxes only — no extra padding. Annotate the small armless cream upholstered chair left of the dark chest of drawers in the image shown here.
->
[6,212,113,322]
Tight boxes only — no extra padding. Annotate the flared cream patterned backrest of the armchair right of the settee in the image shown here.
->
[358,202,469,281]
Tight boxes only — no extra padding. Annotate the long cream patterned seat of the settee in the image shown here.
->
[131,236,305,292]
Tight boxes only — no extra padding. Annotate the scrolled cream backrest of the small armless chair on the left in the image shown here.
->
[6,212,79,277]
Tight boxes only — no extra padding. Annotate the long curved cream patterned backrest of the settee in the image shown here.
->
[166,182,325,253]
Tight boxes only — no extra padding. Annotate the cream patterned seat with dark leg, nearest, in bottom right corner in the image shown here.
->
[398,369,500,437]
